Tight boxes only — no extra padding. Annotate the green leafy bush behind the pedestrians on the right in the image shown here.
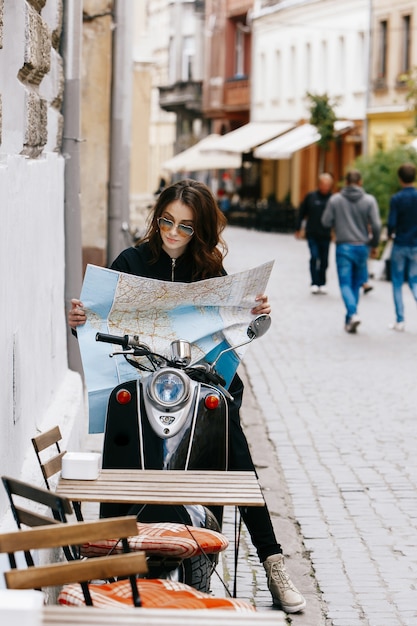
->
[353,146,417,223]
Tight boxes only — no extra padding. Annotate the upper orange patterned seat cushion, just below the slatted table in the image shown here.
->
[81,522,229,559]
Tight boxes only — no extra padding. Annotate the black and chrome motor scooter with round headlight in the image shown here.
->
[96,315,271,591]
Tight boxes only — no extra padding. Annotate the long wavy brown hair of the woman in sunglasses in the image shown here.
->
[139,179,227,280]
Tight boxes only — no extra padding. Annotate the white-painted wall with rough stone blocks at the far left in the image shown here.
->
[0,0,83,526]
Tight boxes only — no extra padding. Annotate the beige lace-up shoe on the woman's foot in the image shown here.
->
[263,554,306,613]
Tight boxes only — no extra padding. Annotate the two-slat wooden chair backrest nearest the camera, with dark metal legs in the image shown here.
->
[0,516,147,606]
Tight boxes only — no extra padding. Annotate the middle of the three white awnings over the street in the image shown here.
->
[204,122,294,154]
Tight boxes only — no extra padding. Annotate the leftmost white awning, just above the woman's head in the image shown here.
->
[162,134,242,173]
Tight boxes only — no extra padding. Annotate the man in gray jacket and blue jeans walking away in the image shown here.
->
[321,170,381,333]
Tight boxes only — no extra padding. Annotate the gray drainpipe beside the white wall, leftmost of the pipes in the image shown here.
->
[62,0,83,373]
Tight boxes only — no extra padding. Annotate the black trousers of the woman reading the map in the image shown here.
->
[213,375,282,563]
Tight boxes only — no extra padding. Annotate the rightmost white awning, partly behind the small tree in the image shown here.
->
[253,120,354,159]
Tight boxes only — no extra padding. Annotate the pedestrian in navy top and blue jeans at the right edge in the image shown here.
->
[388,163,417,331]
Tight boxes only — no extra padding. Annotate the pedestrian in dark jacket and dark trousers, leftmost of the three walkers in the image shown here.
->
[295,173,333,294]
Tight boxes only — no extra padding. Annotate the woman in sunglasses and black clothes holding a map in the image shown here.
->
[68,180,306,613]
